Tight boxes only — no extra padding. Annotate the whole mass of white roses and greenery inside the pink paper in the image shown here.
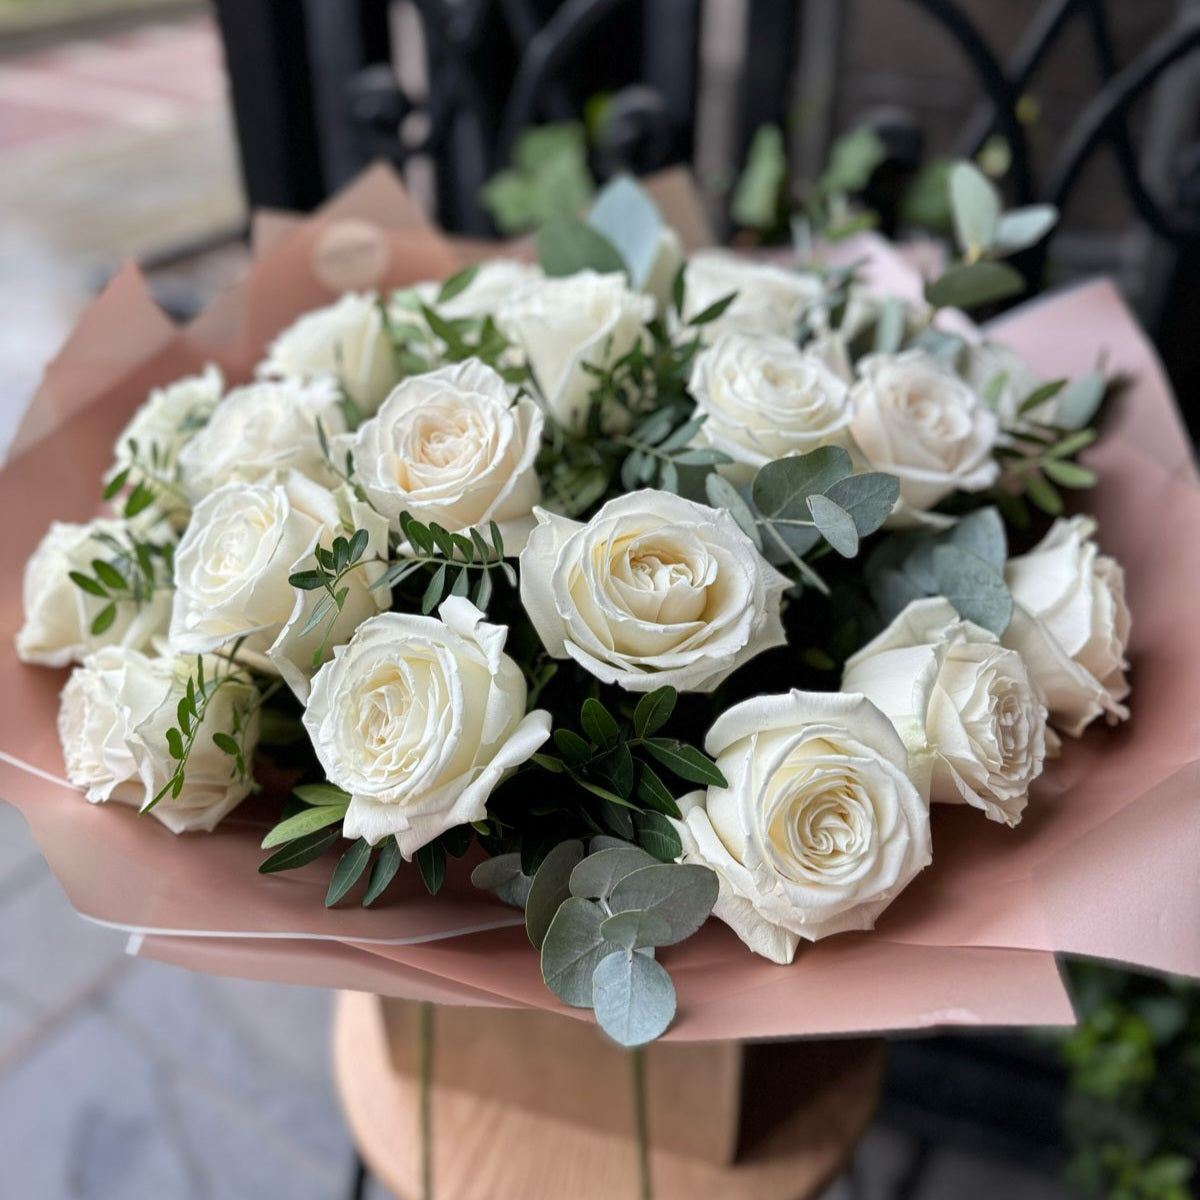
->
[16,167,1129,1044]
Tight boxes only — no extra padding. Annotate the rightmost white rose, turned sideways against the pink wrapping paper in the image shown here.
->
[1003,516,1129,737]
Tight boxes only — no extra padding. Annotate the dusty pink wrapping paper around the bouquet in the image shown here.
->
[0,168,1200,1039]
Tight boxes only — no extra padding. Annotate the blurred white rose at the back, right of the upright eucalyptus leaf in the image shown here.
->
[683,250,824,342]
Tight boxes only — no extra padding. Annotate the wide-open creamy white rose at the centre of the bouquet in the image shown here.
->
[521,491,787,691]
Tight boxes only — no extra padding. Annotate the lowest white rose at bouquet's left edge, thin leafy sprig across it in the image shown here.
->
[59,646,258,833]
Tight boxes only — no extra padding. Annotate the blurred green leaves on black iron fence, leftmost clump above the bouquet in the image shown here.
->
[481,121,593,234]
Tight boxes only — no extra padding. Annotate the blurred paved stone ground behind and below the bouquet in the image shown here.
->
[0,11,1089,1200]
